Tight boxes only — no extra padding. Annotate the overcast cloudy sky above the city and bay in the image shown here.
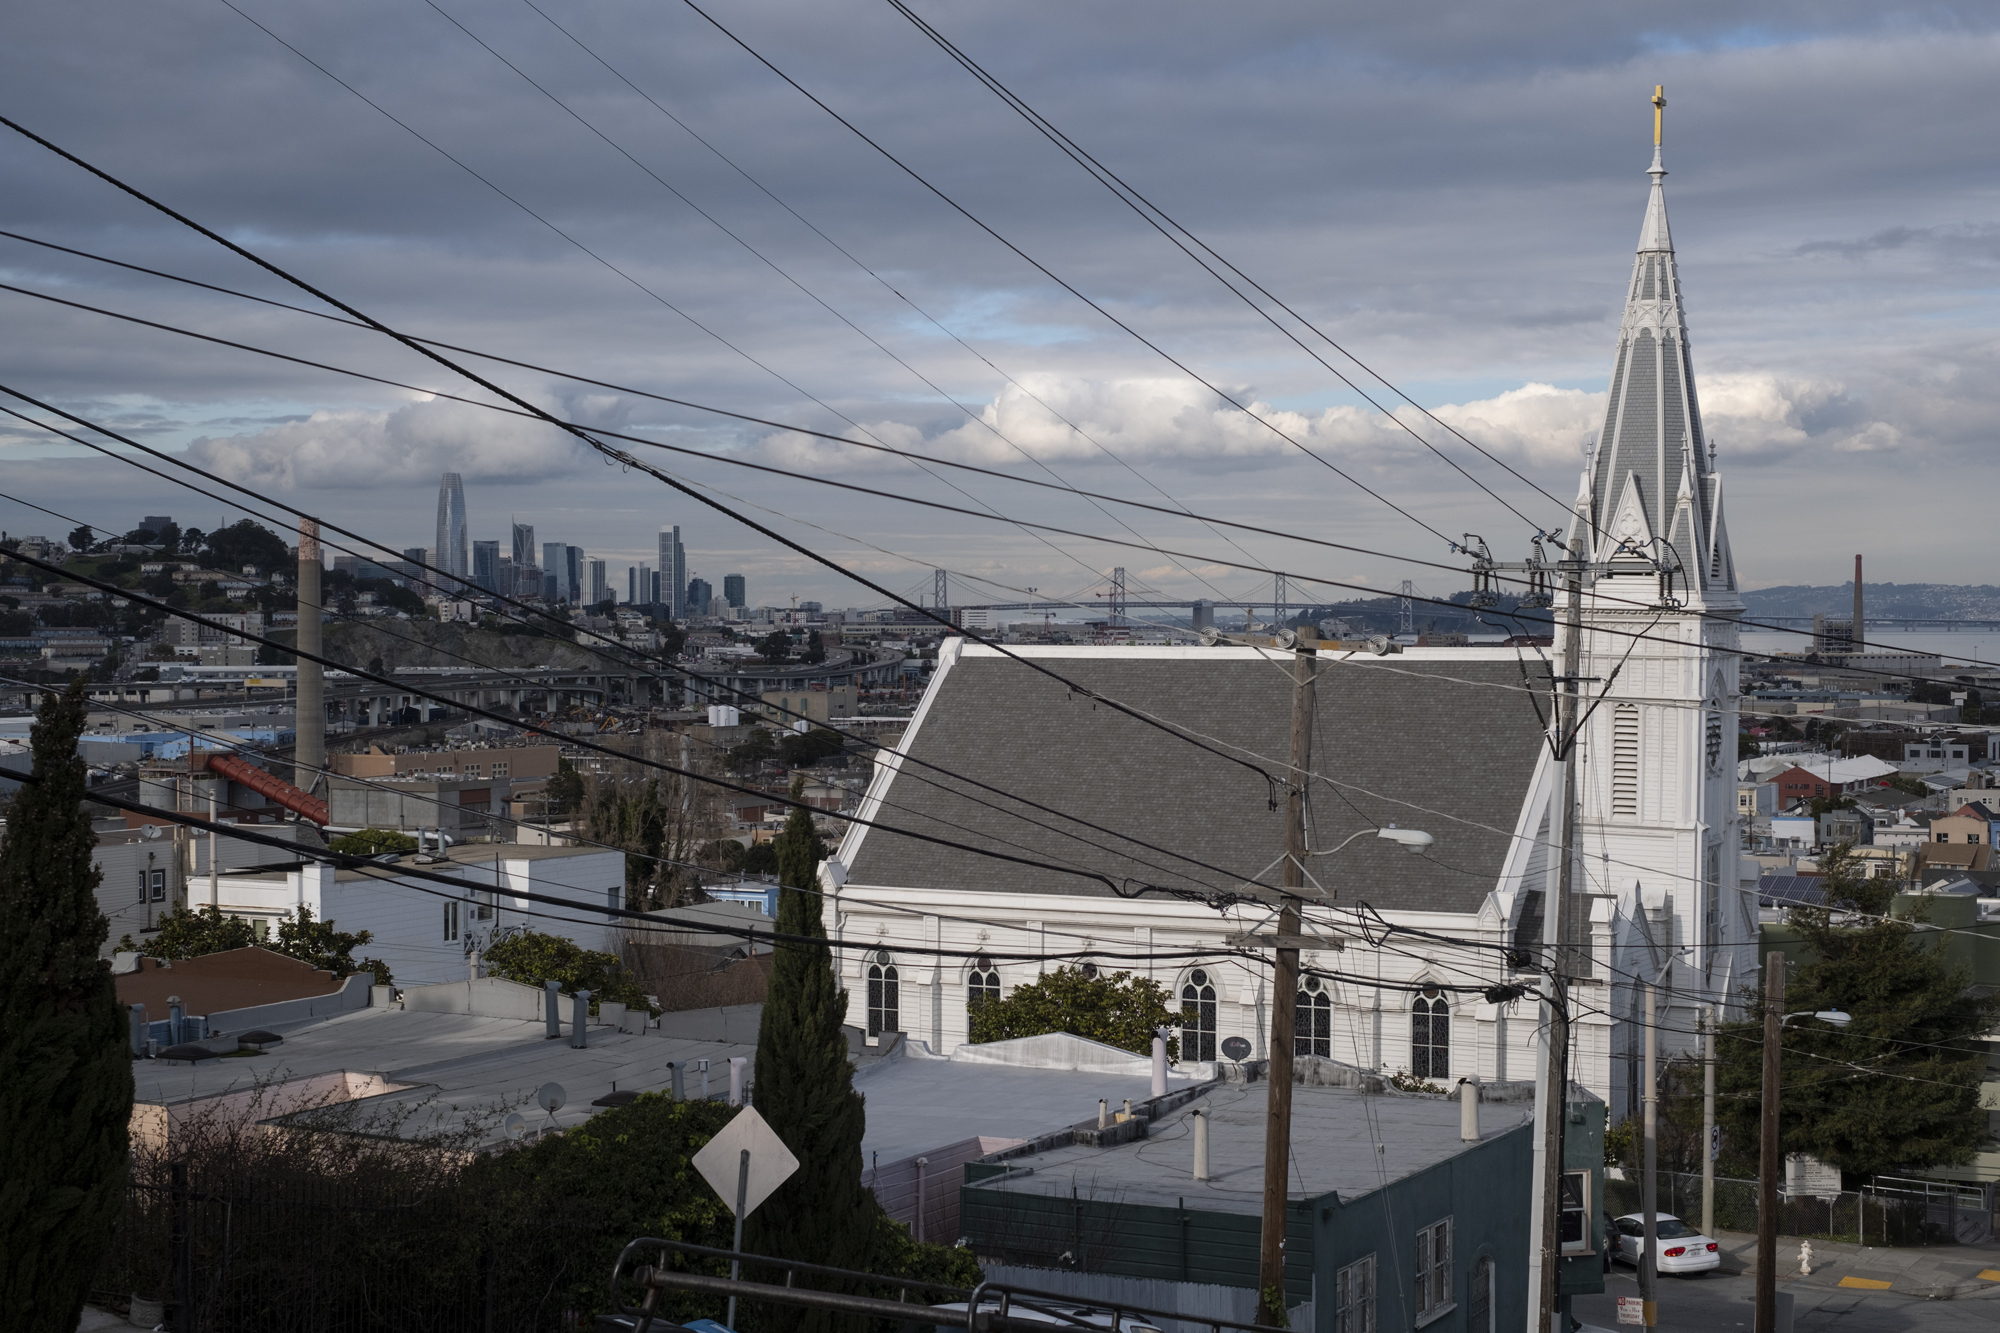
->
[0,0,2000,606]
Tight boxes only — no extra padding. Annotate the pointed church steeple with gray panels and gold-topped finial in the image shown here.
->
[1584,88,1736,596]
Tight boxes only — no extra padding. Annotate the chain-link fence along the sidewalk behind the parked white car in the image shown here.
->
[1604,1171,1994,1247]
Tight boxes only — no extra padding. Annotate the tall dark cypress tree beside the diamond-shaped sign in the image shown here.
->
[744,785,880,1333]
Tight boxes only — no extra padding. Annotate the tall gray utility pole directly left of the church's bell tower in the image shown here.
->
[1528,524,1588,1333]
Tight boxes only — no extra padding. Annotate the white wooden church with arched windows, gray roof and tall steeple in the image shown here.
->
[822,143,1756,1121]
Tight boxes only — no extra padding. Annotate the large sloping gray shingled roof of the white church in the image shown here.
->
[848,644,1548,913]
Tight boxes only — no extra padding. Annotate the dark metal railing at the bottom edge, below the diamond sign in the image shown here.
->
[610,1237,1258,1333]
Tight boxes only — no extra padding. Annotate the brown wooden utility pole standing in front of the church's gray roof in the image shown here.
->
[1256,638,1318,1329]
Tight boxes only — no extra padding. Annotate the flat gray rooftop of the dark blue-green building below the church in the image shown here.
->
[966,1083,1534,1215]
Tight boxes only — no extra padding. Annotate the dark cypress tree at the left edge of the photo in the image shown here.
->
[0,681,132,1333]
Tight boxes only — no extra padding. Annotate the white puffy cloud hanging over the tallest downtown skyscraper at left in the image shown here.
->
[188,400,582,490]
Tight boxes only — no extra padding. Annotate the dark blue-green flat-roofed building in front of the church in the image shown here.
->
[958,1059,1604,1333]
